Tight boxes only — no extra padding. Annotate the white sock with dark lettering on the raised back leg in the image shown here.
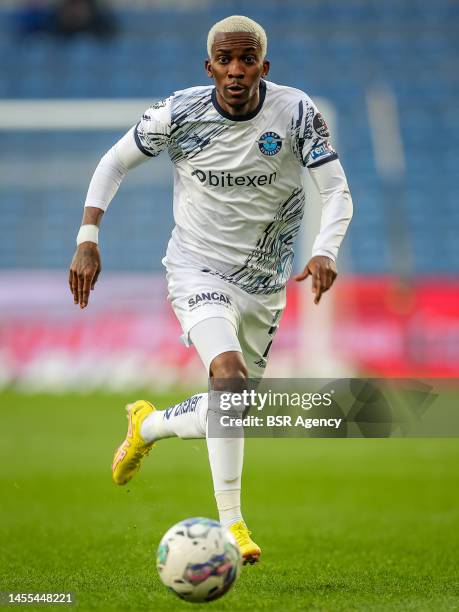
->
[140,393,208,442]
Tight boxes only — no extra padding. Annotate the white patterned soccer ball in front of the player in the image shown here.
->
[156,517,242,602]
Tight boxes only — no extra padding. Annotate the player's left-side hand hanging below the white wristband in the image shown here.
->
[69,242,102,308]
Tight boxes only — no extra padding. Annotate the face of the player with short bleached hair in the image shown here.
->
[205,32,269,117]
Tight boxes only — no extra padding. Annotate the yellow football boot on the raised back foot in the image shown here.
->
[112,400,155,485]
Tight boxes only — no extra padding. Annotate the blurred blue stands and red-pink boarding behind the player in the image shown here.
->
[0,0,459,390]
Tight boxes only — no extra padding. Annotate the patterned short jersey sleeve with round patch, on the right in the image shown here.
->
[291,95,338,168]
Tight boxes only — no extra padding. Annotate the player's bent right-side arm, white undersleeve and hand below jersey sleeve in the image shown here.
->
[294,158,353,304]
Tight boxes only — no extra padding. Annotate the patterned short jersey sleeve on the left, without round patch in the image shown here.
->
[134,96,173,157]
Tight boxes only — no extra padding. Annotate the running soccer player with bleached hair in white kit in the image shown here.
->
[69,16,352,563]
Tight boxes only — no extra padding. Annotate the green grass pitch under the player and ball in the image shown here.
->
[0,392,459,612]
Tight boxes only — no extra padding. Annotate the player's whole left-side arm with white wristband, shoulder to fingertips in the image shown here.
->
[69,98,171,308]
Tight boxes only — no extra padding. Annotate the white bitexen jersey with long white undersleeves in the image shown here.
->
[85,81,352,294]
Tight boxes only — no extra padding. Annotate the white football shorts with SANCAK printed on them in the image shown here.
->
[166,264,286,378]
